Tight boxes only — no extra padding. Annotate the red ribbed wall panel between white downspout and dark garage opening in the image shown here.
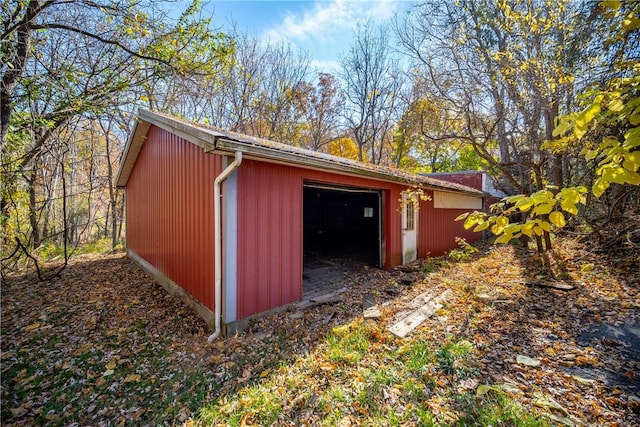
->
[237,160,302,319]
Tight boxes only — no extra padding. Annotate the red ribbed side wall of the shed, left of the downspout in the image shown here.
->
[126,126,221,311]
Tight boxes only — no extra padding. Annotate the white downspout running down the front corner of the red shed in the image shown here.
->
[208,151,242,342]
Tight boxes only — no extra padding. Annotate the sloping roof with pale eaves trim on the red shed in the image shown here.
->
[116,110,483,196]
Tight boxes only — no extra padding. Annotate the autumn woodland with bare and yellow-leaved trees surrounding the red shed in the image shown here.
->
[0,0,640,274]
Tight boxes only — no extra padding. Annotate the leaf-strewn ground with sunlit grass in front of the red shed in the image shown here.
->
[1,240,640,426]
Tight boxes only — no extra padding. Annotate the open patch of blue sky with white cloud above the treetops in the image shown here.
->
[205,0,412,73]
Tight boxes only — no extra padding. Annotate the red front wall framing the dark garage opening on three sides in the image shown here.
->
[237,160,406,319]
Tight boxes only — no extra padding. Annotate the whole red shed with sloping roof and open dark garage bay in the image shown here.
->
[117,111,483,337]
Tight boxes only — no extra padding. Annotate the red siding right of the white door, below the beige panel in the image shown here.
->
[418,191,481,258]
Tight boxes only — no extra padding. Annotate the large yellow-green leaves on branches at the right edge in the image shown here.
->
[467,66,640,252]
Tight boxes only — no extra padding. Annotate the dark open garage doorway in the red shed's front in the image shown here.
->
[303,183,381,297]
